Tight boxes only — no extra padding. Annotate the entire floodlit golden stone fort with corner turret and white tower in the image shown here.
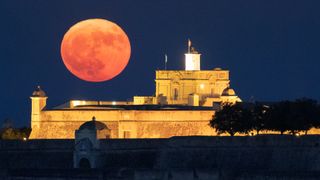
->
[30,42,241,139]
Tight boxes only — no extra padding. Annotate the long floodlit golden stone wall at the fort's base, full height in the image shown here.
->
[30,109,214,139]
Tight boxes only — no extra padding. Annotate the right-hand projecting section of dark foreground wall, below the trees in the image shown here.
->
[156,135,320,172]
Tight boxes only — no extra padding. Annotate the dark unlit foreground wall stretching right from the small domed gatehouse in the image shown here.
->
[98,135,320,175]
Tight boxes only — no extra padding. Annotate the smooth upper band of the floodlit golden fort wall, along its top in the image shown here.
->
[40,109,214,121]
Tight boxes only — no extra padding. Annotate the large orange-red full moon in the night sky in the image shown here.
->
[61,19,131,82]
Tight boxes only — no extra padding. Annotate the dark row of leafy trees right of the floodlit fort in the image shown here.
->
[210,98,320,136]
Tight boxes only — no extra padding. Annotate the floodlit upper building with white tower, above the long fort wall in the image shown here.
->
[133,43,241,107]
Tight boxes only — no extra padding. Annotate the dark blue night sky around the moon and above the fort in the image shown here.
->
[0,0,320,125]
